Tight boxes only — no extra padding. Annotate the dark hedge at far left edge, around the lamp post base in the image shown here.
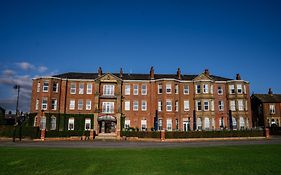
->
[0,125,40,139]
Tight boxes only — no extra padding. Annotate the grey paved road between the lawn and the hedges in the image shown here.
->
[0,137,281,148]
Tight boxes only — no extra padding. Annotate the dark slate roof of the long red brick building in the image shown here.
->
[53,72,232,81]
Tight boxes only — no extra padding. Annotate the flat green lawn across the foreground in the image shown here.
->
[0,145,281,175]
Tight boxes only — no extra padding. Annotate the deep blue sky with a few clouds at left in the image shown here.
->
[0,0,281,111]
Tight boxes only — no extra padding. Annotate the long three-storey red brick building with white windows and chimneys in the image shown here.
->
[30,67,252,135]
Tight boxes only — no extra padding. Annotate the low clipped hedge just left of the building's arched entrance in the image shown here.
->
[45,130,90,138]
